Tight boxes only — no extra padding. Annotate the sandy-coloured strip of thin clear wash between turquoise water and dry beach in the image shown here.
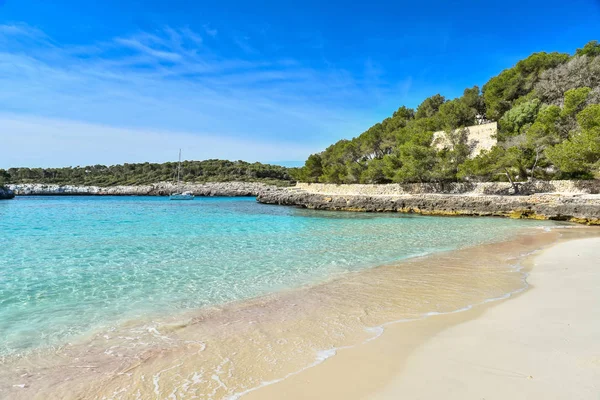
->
[0,223,585,398]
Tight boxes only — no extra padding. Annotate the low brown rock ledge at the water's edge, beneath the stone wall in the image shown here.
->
[258,187,600,225]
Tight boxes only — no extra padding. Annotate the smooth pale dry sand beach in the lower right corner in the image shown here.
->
[245,230,600,400]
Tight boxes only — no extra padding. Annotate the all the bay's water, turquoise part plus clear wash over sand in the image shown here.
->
[0,197,556,398]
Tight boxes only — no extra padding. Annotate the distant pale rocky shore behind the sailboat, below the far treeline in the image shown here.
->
[9,182,277,196]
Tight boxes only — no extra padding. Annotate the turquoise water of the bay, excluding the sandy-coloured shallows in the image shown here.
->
[0,197,552,355]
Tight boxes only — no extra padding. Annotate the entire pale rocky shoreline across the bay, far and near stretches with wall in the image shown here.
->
[9,181,600,225]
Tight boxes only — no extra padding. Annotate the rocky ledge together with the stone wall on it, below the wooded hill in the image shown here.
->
[258,181,600,225]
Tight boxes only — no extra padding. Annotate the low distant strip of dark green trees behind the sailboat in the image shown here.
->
[0,160,291,186]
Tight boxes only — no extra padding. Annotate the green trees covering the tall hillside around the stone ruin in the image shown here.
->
[295,41,600,183]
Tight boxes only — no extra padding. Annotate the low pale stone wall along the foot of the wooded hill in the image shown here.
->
[296,179,600,196]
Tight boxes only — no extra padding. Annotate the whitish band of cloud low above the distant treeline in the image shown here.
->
[0,114,317,169]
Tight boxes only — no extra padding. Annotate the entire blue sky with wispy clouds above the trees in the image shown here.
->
[0,0,600,168]
